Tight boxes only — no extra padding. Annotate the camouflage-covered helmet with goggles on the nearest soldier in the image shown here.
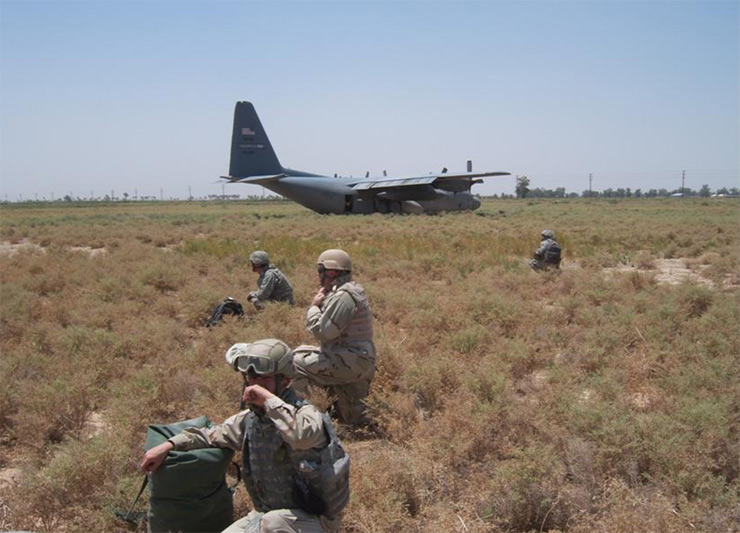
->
[226,339,293,377]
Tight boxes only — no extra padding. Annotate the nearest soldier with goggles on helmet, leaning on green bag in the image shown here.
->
[140,339,349,533]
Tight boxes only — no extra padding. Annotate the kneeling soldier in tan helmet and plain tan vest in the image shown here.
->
[293,250,375,425]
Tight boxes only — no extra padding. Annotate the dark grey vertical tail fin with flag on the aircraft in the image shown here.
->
[229,102,284,178]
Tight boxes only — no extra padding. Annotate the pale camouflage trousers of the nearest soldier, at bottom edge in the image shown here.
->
[222,509,337,533]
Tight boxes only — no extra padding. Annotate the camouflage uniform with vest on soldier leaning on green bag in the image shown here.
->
[169,388,341,533]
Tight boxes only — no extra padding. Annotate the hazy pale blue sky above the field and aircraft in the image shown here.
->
[0,0,740,201]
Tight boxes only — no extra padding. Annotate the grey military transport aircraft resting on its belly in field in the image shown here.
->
[221,102,510,214]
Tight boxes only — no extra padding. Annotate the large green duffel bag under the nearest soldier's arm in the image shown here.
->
[146,416,234,533]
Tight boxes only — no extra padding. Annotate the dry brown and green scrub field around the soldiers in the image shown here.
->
[0,198,740,533]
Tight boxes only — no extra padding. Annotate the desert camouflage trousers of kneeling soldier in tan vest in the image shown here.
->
[293,345,375,425]
